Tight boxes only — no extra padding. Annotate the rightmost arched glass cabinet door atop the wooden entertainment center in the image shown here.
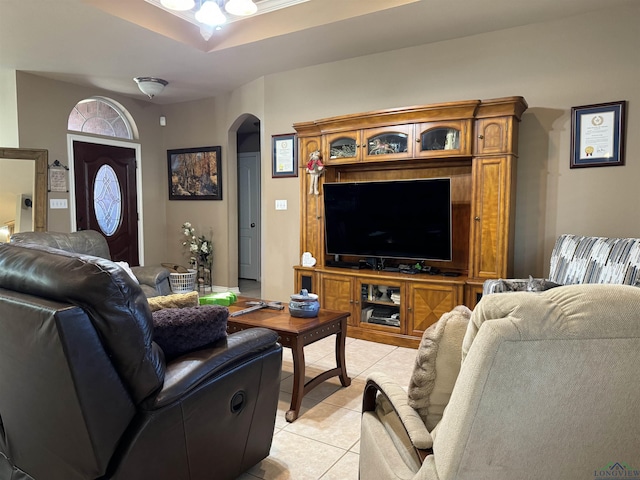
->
[416,120,471,157]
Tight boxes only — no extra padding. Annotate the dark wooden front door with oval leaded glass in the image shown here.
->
[73,141,140,266]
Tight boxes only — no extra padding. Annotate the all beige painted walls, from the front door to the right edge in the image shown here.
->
[6,6,640,300]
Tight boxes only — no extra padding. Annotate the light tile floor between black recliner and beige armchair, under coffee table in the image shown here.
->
[238,328,416,480]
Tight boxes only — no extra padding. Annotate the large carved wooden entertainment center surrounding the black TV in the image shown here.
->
[294,97,527,347]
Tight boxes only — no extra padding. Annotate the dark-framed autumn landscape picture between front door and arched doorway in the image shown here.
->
[167,147,222,200]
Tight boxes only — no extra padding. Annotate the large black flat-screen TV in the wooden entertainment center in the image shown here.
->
[323,178,452,261]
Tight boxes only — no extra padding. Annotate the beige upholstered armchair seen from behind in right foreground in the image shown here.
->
[360,284,640,480]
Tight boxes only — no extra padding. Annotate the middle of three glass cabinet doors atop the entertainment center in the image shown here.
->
[363,125,413,160]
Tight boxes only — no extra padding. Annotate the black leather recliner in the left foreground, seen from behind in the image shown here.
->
[0,244,282,480]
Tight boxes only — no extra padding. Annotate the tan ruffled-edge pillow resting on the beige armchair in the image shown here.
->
[408,305,471,431]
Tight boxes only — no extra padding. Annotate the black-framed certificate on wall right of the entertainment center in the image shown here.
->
[571,100,626,168]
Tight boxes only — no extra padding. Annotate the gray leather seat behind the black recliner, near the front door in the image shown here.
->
[10,230,171,297]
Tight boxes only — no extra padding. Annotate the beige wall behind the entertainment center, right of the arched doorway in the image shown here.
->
[256,6,640,298]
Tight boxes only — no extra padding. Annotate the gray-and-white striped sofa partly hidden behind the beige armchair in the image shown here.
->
[482,234,640,295]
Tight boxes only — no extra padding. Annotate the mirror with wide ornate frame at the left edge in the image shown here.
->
[0,148,49,242]
